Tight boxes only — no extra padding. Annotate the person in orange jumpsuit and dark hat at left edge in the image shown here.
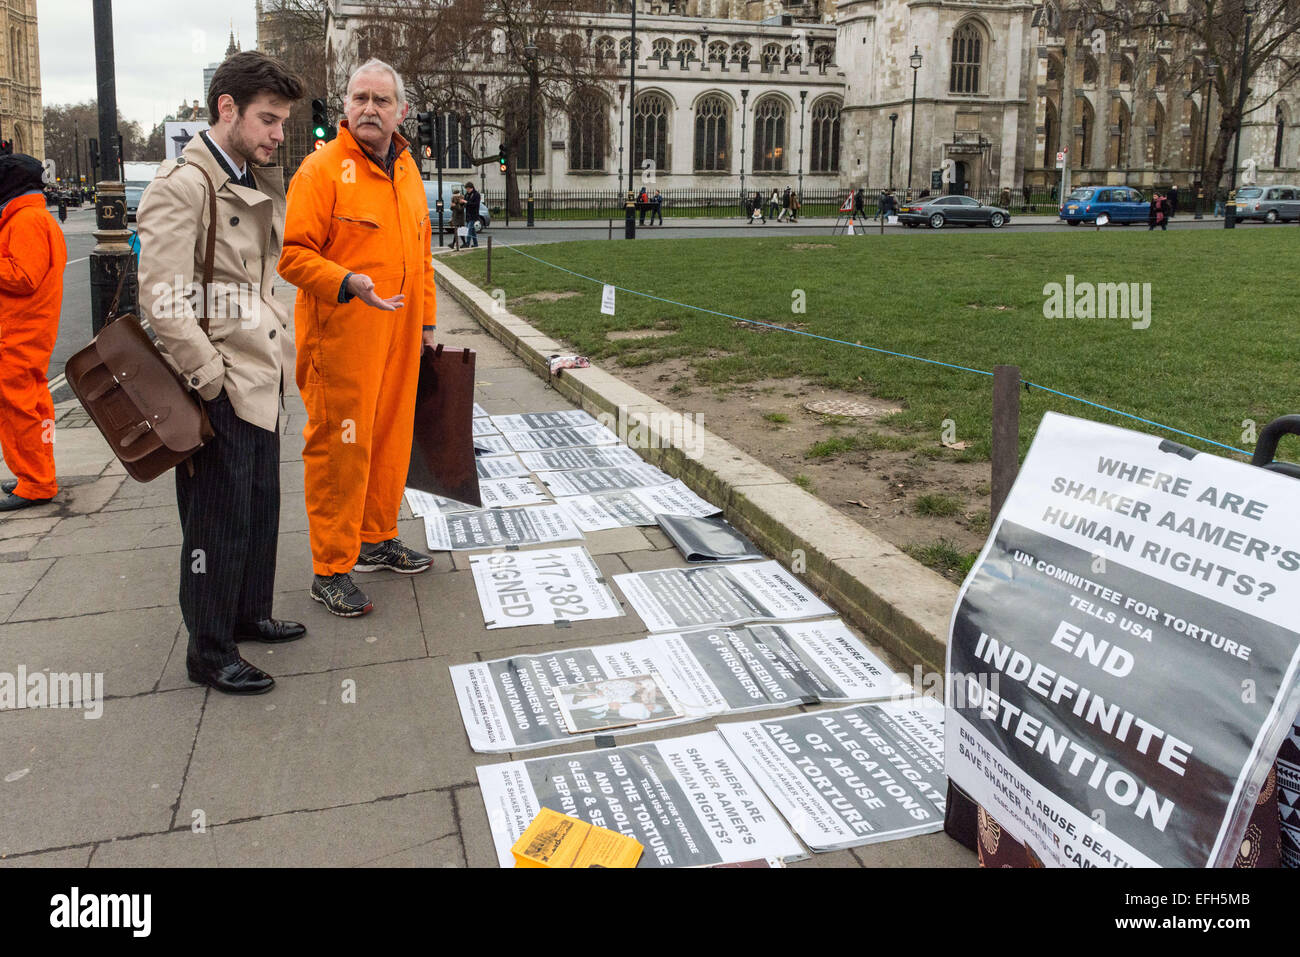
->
[0,153,68,511]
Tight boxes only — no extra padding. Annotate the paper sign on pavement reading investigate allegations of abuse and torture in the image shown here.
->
[718,697,948,850]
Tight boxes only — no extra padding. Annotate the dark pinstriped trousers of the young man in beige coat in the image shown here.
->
[176,391,280,668]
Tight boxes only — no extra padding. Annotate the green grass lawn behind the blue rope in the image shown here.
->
[445,226,1300,459]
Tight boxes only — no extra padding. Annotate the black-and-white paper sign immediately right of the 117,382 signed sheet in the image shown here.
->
[614,562,835,632]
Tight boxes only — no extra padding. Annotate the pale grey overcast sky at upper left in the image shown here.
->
[36,0,257,128]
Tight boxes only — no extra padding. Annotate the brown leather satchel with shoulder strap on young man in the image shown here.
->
[64,164,217,482]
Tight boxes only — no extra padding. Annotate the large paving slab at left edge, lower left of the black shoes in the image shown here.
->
[0,688,205,854]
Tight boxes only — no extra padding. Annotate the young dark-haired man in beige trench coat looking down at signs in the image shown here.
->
[137,51,307,694]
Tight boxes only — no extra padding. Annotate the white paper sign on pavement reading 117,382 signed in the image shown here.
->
[469,545,623,629]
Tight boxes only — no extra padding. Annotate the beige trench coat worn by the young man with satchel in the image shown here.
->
[137,137,294,432]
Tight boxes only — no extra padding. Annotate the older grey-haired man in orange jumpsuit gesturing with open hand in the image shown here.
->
[280,60,437,618]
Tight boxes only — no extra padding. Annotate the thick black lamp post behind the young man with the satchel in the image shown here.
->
[90,0,138,335]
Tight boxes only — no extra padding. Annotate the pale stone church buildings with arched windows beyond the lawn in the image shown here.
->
[309,0,1300,195]
